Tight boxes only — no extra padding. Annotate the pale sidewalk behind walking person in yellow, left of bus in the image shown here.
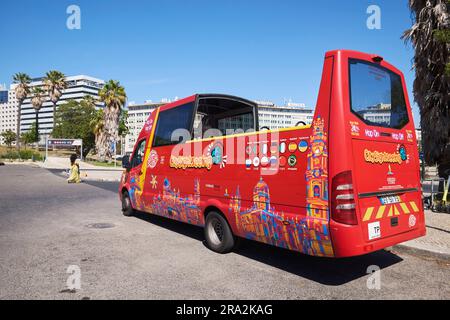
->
[39,157,123,181]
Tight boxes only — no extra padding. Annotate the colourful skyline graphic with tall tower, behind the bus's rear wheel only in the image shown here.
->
[229,117,334,257]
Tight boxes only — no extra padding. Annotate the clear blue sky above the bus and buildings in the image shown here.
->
[0,0,419,126]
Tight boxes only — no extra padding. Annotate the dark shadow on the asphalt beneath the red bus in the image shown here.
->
[135,212,403,286]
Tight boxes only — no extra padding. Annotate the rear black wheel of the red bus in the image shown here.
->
[204,211,236,253]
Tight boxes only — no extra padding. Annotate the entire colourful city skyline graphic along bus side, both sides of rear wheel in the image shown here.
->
[134,117,334,257]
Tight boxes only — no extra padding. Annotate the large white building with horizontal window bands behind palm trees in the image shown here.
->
[19,75,105,140]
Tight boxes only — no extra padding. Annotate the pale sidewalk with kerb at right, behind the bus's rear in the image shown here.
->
[392,210,450,261]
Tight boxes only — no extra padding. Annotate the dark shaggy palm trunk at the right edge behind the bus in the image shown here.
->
[403,0,450,178]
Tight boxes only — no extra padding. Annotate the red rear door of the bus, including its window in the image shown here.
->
[347,59,424,242]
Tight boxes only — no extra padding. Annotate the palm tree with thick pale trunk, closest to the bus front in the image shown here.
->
[97,80,127,161]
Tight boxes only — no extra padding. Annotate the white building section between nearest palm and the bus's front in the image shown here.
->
[125,101,164,153]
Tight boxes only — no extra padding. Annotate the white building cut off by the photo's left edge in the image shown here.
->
[0,86,18,144]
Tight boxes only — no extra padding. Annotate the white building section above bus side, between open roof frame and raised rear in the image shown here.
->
[255,101,314,129]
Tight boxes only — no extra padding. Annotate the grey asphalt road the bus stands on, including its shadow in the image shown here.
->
[0,165,450,299]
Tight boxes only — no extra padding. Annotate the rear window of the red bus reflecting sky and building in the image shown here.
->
[350,59,409,129]
